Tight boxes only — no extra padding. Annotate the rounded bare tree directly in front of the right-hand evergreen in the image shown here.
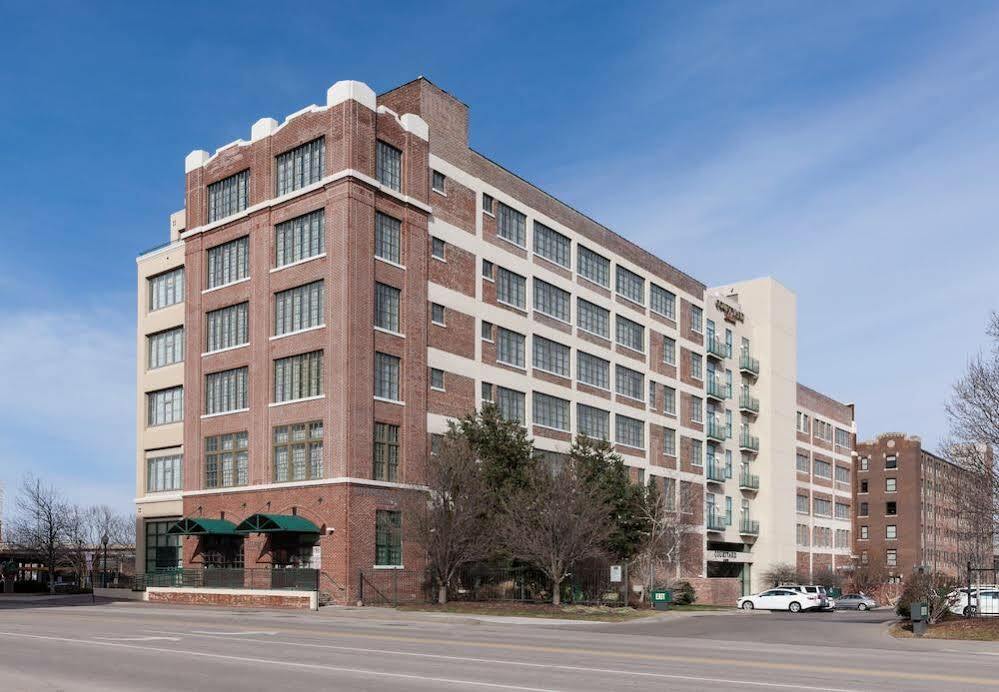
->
[498,457,612,605]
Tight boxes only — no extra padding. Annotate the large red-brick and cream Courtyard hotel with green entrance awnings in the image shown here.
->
[137,78,860,600]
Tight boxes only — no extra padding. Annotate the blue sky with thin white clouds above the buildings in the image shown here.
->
[0,0,999,509]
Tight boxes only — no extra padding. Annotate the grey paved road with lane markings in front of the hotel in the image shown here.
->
[0,601,999,692]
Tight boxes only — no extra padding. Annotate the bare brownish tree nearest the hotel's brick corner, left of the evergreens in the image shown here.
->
[411,430,491,604]
